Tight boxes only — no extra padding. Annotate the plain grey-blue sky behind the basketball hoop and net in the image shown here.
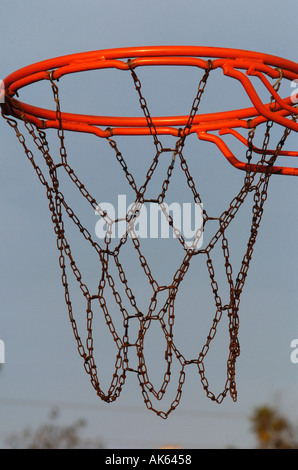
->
[0,0,298,448]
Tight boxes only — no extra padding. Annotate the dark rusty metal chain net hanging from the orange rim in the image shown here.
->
[2,61,296,419]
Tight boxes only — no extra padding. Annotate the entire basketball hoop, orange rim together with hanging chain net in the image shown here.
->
[1,46,298,418]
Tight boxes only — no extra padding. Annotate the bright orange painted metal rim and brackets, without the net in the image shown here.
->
[2,46,298,176]
